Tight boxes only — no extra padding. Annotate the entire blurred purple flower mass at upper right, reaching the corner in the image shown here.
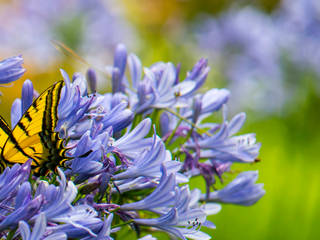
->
[196,0,320,114]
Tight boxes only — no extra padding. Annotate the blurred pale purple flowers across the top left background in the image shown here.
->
[0,0,137,68]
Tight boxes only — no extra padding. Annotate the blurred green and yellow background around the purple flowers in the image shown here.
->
[0,0,320,240]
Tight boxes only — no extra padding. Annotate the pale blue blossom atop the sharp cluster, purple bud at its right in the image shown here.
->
[126,48,209,113]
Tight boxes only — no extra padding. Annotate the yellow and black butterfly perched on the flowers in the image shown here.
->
[0,81,70,175]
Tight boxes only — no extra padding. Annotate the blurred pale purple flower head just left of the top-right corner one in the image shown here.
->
[197,7,284,111]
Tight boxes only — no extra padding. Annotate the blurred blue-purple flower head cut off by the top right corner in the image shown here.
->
[272,0,320,75]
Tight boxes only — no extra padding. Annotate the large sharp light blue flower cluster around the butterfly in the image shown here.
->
[0,45,265,239]
